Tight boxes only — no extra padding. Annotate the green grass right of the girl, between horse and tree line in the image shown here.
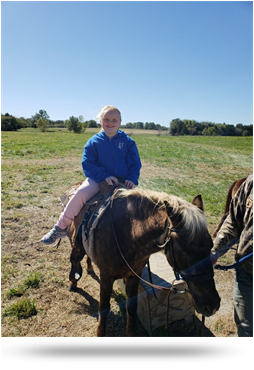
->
[135,136,253,216]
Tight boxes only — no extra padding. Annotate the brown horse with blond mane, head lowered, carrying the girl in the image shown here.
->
[70,188,220,337]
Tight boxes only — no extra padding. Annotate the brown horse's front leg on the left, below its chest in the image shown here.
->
[97,274,114,337]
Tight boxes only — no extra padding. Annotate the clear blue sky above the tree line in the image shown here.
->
[1,1,253,126]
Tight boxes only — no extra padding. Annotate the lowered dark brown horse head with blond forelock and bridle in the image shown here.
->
[166,195,220,317]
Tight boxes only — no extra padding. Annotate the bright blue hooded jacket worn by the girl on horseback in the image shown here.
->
[82,130,142,185]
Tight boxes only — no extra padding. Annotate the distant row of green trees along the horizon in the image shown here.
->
[1,109,253,136]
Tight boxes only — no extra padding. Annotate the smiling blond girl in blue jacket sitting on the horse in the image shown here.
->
[41,105,141,244]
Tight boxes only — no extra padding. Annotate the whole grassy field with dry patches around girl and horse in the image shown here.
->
[1,129,253,336]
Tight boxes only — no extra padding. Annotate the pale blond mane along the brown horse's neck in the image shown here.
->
[114,188,207,241]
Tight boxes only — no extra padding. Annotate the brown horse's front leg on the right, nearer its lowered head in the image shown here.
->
[125,276,139,337]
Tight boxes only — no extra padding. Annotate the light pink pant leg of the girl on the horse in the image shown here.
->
[57,179,100,229]
